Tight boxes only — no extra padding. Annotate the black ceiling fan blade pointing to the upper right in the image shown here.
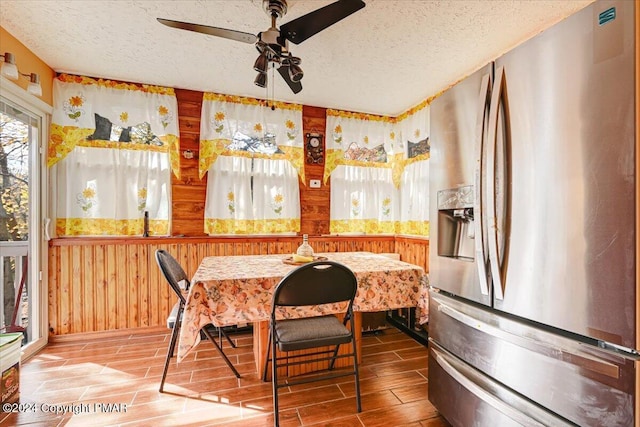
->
[280,0,365,44]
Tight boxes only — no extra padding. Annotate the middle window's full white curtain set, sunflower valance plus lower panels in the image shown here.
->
[199,93,305,235]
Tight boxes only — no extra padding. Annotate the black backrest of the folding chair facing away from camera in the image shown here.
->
[272,261,358,314]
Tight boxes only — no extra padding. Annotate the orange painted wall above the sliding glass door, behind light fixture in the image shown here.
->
[0,27,55,105]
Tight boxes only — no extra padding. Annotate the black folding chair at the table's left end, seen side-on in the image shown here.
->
[156,249,240,392]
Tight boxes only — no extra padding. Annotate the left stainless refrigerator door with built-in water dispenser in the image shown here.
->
[429,64,492,305]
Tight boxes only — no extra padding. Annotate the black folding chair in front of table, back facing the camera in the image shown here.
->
[263,261,362,426]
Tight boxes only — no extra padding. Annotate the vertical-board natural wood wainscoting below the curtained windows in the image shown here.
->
[48,236,429,335]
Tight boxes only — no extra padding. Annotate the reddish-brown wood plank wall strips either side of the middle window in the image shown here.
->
[172,89,330,236]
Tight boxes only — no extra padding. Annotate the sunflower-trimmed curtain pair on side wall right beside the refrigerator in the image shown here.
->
[397,100,430,237]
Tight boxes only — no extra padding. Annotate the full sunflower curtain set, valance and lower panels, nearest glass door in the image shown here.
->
[47,74,179,236]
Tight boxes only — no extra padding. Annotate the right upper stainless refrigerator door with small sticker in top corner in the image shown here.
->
[490,0,637,349]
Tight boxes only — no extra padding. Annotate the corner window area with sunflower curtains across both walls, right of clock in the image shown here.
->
[324,102,430,236]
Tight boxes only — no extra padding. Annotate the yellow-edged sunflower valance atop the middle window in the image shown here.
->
[199,93,305,182]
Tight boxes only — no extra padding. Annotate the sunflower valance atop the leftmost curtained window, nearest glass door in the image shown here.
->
[47,74,180,177]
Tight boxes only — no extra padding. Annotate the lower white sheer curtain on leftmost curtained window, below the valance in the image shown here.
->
[54,147,171,235]
